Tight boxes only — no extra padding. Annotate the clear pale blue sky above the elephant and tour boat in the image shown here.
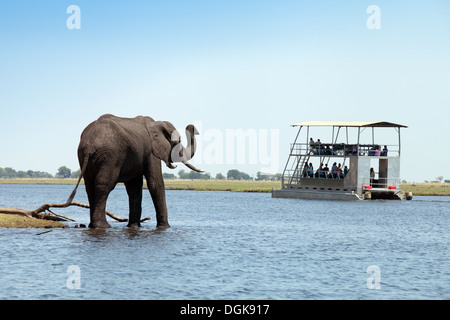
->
[0,0,450,181]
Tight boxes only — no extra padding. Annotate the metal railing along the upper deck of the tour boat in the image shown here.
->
[291,143,400,157]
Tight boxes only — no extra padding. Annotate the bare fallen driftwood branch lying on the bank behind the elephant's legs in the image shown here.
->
[0,201,150,222]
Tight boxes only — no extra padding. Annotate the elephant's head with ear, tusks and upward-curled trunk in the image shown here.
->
[149,121,204,172]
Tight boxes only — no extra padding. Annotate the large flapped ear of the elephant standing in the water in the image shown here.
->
[149,121,181,169]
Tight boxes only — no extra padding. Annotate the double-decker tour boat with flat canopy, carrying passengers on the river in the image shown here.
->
[272,122,409,200]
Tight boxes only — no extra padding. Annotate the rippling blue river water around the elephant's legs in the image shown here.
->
[0,185,450,300]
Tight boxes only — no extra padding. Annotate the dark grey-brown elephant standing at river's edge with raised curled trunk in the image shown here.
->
[67,114,203,229]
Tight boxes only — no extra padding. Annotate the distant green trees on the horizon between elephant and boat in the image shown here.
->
[163,169,281,181]
